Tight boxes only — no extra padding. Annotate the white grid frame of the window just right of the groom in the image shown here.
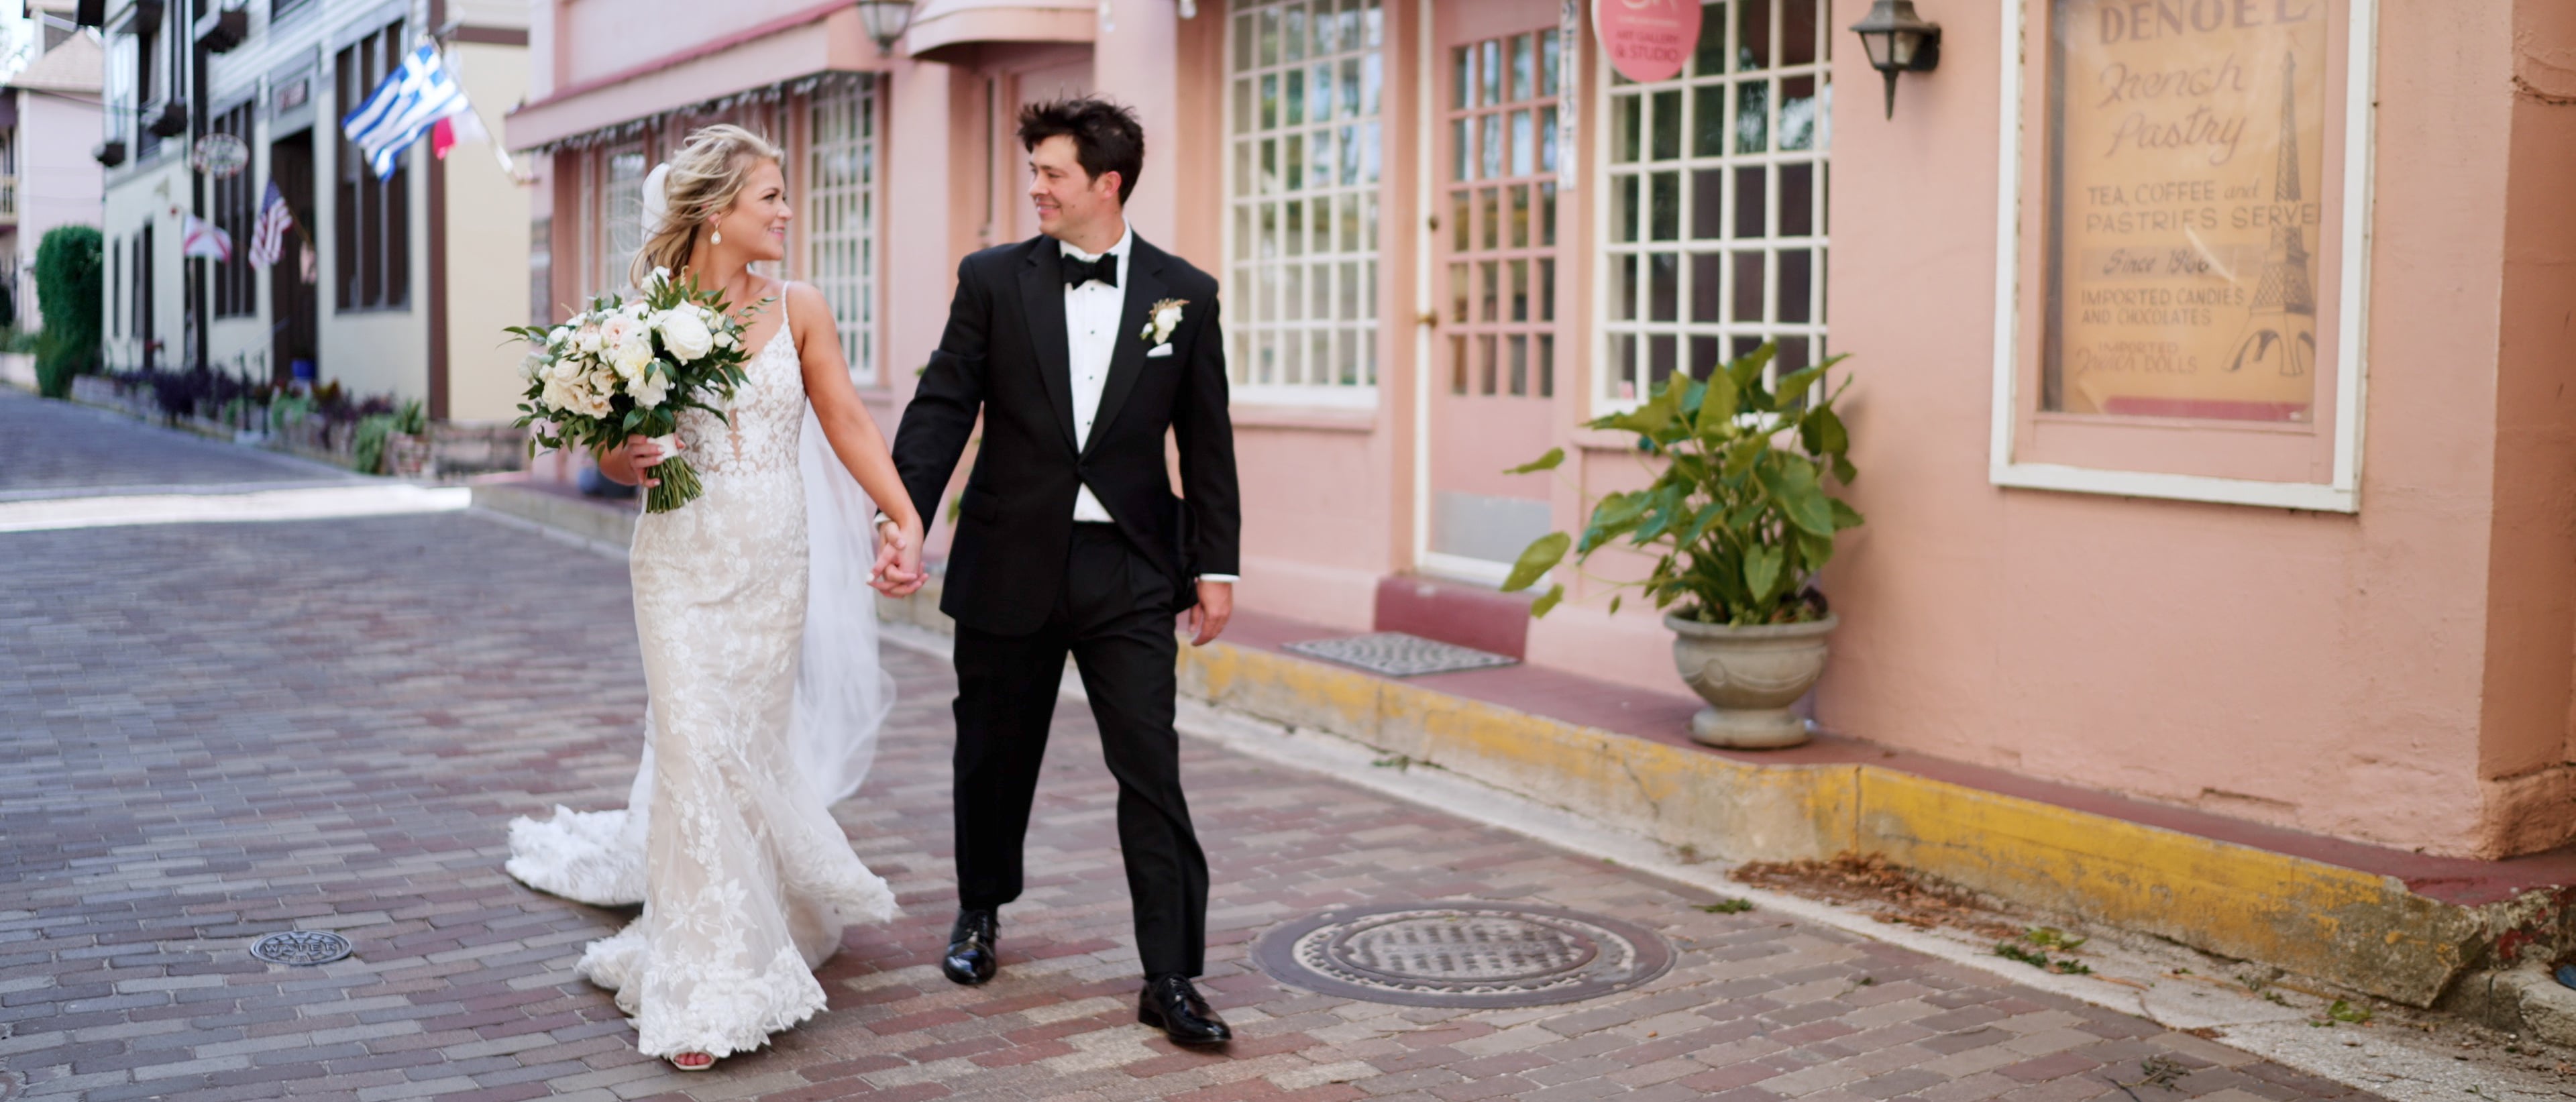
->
[1221,0,1389,409]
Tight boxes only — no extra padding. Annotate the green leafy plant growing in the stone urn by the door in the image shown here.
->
[1502,345,1860,626]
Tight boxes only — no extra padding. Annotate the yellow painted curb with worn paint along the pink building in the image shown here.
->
[1180,644,2488,1007]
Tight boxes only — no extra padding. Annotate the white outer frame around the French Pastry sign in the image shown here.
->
[1986,0,2380,512]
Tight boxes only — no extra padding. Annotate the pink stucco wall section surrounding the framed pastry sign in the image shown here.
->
[1819,0,2576,855]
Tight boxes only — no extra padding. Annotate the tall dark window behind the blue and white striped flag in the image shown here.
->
[332,21,412,309]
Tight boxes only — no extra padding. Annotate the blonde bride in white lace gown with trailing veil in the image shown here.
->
[507,126,922,1071]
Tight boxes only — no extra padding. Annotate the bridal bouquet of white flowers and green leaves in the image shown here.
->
[507,268,749,512]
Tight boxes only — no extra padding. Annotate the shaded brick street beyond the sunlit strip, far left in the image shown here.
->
[0,386,350,500]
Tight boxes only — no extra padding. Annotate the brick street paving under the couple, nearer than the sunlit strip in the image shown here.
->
[0,515,2367,1102]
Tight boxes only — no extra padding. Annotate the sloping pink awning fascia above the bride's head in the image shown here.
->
[502,0,883,150]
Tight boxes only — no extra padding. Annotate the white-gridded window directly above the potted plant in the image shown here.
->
[1595,0,1831,407]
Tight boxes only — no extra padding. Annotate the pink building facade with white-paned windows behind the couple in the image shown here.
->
[507,0,2576,857]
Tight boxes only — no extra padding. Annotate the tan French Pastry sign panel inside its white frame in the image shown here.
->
[2040,0,2331,423]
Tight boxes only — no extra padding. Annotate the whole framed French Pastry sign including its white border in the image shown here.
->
[1991,0,2375,512]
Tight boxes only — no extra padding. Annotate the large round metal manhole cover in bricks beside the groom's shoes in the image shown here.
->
[1252,901,1672,1007]
